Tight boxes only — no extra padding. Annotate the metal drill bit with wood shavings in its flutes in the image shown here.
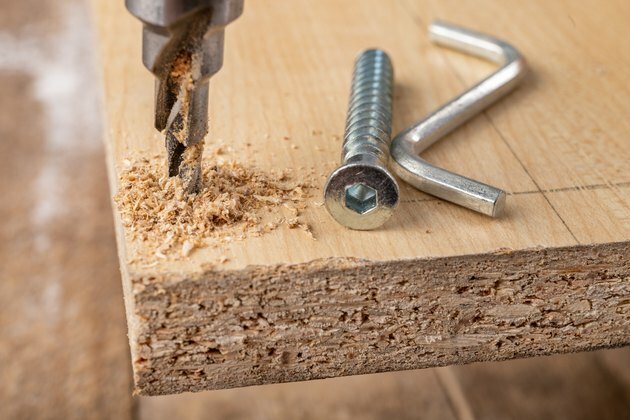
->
[125,0,244,193]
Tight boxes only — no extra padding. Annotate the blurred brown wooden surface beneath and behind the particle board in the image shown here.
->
[0,0,630,419]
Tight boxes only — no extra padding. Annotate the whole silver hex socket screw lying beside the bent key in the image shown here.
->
[324,49,399,230]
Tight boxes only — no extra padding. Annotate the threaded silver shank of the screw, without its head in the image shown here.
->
[342,49,394,167]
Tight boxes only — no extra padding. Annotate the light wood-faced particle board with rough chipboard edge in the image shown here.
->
[94,0,630,394]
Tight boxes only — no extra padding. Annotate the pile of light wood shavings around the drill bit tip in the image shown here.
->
[114,156,310,258]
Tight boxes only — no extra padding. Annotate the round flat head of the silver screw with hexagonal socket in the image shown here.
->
[324,163,399,230]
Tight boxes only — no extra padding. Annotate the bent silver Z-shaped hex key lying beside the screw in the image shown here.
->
[390,22,527,217]
